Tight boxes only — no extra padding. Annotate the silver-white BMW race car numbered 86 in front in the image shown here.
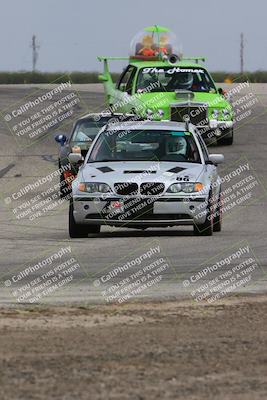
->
[69,121,224,238]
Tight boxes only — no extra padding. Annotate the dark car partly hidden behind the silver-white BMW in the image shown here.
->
[55,112,140,198]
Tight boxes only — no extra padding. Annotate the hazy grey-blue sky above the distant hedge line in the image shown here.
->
[0,0,267,71]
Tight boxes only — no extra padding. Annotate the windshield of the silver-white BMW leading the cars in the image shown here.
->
[88,130,201,163]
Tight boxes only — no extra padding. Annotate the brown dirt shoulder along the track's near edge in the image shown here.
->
[0,296,267,400]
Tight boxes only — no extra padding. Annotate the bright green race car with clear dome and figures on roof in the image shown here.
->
[98,25,234,145]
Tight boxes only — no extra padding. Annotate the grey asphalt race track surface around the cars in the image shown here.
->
[0,85,267,306]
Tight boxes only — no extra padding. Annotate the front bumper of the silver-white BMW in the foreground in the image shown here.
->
[73,195,208,226]
